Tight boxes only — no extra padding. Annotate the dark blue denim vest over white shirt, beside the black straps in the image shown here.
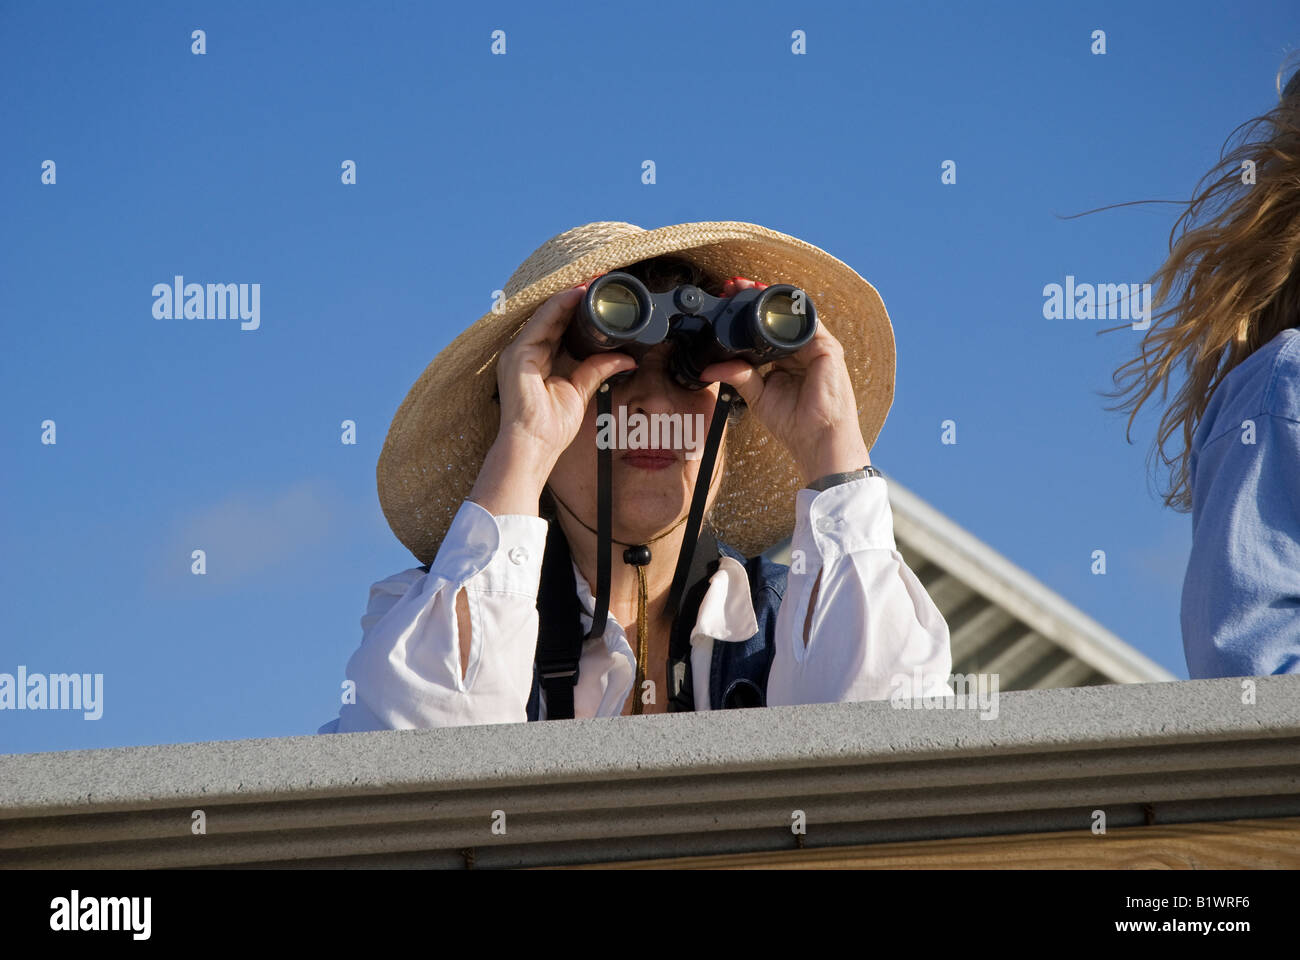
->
[528,541,789,721]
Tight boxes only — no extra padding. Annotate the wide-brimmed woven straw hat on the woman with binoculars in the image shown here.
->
[376,221,894,563]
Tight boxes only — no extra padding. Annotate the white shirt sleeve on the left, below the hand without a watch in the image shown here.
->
[322,501,546,732]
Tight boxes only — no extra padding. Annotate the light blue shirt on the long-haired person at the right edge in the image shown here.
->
[1182,328,1300,679]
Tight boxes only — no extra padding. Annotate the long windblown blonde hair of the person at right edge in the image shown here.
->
[1106,64,1300,511]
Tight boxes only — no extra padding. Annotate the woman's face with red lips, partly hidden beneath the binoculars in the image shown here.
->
[550,341,725,544]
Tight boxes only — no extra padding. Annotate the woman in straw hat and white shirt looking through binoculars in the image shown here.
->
[322,222,952,732]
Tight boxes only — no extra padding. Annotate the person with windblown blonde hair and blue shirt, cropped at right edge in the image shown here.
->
[1115,72,1300,679]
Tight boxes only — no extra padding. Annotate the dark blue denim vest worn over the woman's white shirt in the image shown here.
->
[528,541,789,721]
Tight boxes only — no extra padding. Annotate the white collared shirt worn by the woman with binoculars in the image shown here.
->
[320,476,952,734]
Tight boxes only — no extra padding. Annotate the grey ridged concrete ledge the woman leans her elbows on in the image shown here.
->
[0,676,1300,866]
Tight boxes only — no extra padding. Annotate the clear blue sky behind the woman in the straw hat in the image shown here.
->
[0,0,1300,752]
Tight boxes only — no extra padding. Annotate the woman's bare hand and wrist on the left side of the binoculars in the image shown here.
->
[469,284,637,515]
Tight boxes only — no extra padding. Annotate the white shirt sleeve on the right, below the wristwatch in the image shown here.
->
[767,476,952,706]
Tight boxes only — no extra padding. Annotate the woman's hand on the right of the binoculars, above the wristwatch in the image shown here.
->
[701,277,871,484]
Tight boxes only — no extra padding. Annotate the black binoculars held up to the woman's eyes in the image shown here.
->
[564,271,816,390]
